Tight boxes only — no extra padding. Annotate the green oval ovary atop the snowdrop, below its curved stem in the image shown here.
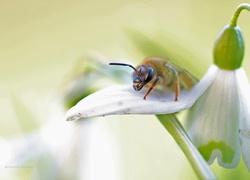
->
[213,25,244,70]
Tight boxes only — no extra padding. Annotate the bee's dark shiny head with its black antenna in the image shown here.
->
[109,63,154,91]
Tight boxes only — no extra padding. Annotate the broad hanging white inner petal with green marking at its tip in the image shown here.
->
[186,67,240,168]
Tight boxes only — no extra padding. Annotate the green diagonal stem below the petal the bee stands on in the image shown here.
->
[156,114,216,179]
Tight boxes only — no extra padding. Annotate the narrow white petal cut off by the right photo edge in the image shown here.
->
[237,68,250,171]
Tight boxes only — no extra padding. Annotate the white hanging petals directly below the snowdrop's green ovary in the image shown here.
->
[186,68,250,168]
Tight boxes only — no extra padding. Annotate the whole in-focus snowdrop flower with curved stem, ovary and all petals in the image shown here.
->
[66,4,250,174]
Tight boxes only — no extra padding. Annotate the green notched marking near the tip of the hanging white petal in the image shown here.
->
[198,141,235,164]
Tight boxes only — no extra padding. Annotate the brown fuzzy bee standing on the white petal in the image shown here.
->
[109,57,199,101]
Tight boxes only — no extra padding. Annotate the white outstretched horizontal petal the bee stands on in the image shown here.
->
[66,65,217,121]
